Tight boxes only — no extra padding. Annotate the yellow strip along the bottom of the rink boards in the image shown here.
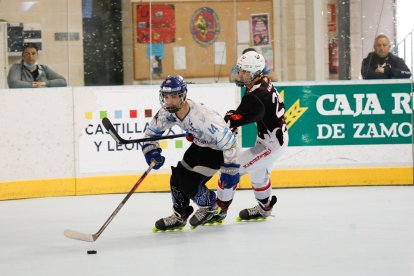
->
[0,167,414,200]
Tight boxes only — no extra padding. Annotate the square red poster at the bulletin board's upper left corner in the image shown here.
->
[135,4,175,43]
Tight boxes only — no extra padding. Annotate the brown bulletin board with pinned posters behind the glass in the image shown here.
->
[132,0,274,81]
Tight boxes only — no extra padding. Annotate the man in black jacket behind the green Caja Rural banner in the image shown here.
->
[361,34,411,80]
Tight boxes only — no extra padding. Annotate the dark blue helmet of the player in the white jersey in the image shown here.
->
[160,75,187,113]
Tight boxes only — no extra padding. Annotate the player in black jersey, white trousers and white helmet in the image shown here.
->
[212,51,289,221]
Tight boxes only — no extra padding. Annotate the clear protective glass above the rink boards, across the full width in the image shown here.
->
[0,0,414,86]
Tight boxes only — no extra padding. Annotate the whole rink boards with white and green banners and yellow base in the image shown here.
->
[0,82,413,200]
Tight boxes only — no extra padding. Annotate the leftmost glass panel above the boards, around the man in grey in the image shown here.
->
[0,0,72,85]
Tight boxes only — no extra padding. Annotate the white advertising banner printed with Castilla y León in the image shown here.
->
[74,85,237,175]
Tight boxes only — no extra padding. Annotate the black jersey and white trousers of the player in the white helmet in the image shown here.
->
[217,77,289,201]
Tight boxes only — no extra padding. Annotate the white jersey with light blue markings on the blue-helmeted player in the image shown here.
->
[145,99,236,151]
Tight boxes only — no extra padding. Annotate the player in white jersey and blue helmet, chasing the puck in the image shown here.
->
[142,75,240,231]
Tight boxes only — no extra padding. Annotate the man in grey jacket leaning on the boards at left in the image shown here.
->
[7,43,67,88]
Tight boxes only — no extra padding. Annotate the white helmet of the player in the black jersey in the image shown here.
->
[231,51,266,86]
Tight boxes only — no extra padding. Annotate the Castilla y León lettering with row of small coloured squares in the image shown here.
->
[83,109,183,152]
